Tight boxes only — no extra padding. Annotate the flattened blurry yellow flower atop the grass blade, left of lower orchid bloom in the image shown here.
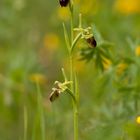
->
[29,73,47,84]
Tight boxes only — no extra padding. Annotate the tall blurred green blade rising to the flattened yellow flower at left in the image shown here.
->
[36,81,45,140]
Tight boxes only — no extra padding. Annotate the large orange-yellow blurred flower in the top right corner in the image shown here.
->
[114,0,140,15]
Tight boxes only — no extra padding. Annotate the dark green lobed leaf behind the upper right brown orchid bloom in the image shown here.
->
[80,25,112,71]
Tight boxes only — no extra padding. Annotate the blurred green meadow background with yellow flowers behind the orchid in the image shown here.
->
[0,0,140,140]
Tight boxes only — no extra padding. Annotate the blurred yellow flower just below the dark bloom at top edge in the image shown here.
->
[57,7,70,21]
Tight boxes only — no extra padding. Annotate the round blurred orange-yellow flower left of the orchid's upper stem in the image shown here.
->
[44,33,59,50]
